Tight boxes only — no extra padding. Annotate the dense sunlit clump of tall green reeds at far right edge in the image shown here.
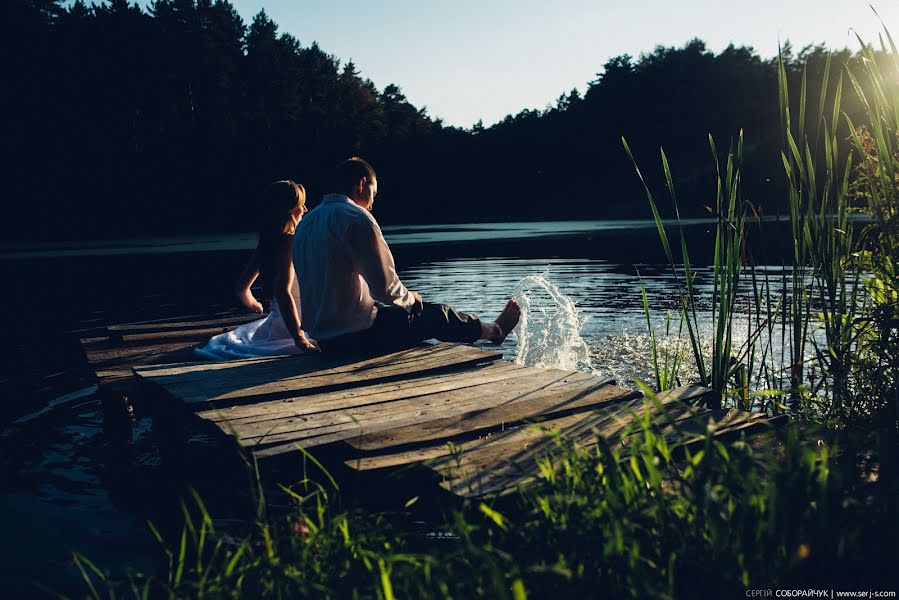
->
[779,28,899,429]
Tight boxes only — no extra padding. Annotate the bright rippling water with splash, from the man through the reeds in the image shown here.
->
[401,257,804,385]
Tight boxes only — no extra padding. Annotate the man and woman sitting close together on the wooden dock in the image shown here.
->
[199,158,520,359]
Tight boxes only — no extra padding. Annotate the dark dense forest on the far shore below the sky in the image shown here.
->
[0,0,858,240]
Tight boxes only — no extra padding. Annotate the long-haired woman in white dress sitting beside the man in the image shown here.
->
[197,180,318,359]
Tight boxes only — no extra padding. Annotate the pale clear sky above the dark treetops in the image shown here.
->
[141,0,899,128]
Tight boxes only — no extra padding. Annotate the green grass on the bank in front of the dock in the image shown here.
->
[75,410,899,598]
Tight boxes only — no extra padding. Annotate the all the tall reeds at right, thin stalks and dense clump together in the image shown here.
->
[636,21,899,427]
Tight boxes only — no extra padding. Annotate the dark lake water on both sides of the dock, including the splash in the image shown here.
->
[0,221,800,595]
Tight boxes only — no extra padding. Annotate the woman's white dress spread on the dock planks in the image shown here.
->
[194,279,303,360]
